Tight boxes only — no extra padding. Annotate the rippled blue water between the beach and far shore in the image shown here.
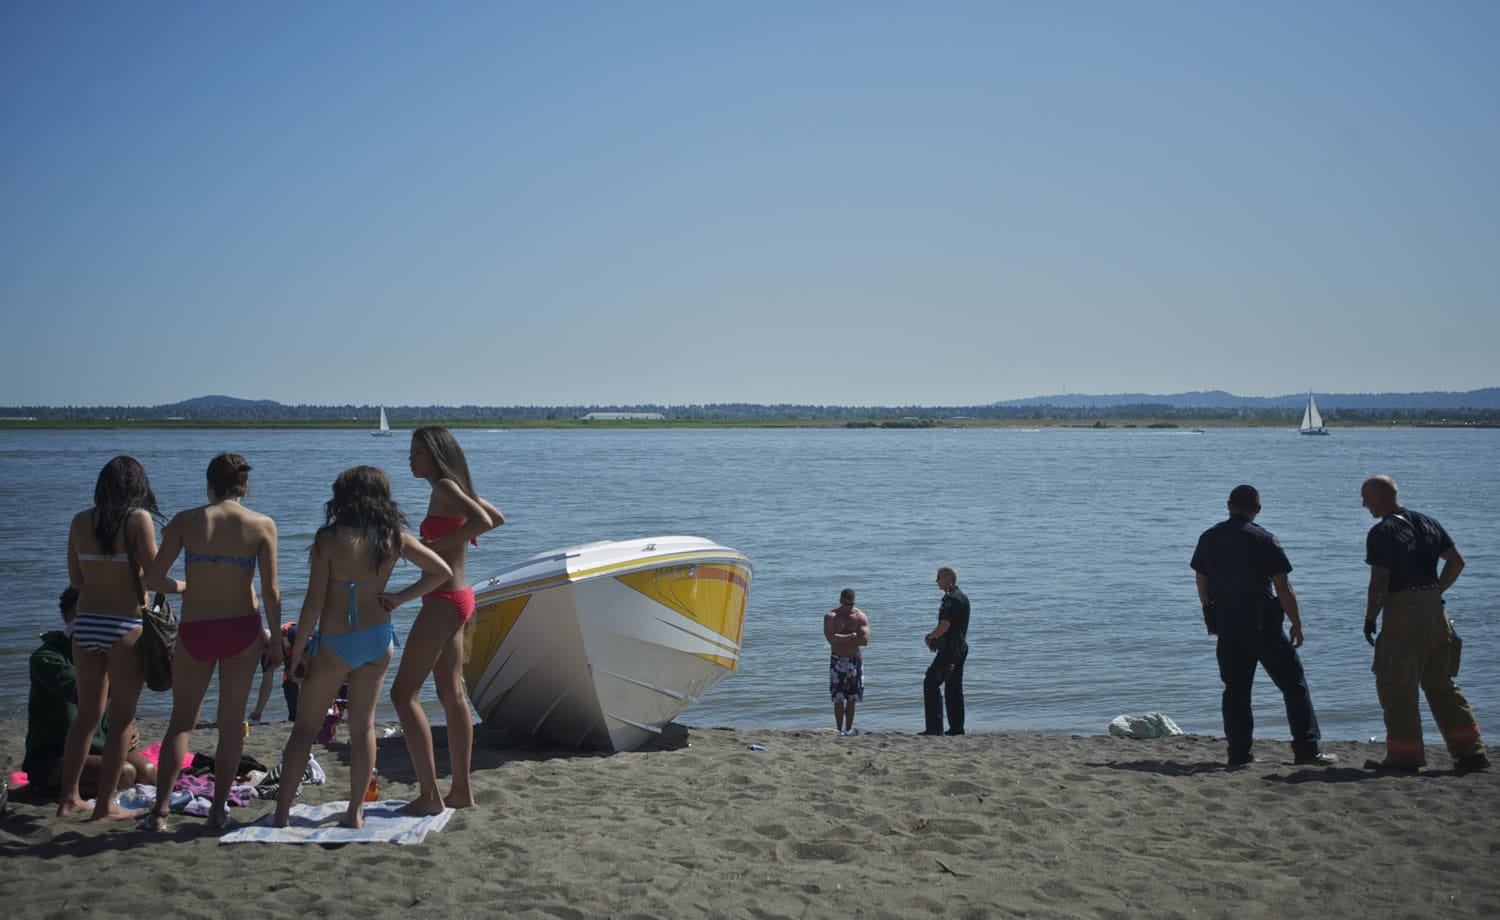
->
[0,428,1500,738]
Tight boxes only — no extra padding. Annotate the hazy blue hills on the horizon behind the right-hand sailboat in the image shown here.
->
[992,387,1500,411]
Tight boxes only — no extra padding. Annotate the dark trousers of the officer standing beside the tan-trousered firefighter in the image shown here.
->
[1218,623,1322,762]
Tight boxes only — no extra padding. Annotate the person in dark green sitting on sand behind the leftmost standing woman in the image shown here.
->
[21,587,156,795]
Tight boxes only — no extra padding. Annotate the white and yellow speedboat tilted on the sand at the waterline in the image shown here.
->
[464,536,750,750]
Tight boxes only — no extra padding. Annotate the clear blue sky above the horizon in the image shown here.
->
[0,0,1500,405]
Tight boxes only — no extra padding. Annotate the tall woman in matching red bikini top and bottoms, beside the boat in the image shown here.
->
[390,428,506,815]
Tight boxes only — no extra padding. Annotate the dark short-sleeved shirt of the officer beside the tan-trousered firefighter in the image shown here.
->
[1190,515,1292,623]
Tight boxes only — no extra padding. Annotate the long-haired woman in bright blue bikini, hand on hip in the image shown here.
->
[276,467,453,828]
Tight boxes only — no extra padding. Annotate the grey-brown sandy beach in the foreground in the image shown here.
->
[0,722,1500,917]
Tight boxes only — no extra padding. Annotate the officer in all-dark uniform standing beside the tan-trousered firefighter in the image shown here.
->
[1191,485,1338,767]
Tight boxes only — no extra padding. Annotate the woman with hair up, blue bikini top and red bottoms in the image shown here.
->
[146,453,282,830]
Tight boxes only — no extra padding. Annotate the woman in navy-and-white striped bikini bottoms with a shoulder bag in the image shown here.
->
[57,456,182,819]
